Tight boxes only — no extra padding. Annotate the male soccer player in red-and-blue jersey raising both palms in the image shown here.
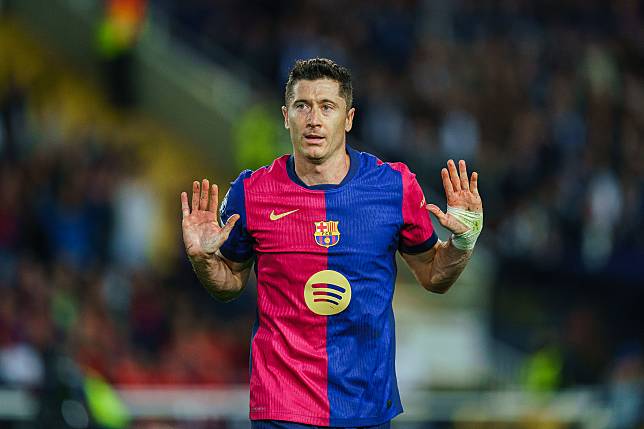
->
[181,58,483,428]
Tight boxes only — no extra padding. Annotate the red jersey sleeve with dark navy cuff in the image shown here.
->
[394,163,438,254]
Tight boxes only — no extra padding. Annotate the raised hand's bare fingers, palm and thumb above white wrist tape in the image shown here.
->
[426,159,483,234]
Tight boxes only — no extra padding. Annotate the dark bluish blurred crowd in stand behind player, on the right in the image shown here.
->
[155,0,644,387]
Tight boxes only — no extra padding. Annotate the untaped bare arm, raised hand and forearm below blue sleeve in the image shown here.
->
[181,179,252,301]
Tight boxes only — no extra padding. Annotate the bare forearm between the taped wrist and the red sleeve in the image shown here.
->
[423,238,472,293]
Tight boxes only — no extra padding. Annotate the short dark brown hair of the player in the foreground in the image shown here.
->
[284,58,353,110]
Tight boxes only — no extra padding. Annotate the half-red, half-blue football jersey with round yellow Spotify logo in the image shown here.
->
[220,147,437,426]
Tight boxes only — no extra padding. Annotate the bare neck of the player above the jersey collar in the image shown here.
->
[294,145,351,186]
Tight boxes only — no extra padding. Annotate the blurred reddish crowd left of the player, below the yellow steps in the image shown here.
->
[0,82,248,386]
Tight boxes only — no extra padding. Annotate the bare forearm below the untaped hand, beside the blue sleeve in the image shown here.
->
[189,254,249,302]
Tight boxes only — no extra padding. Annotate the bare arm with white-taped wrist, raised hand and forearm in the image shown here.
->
[402,160,483,293]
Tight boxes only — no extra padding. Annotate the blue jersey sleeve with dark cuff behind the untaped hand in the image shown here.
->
[219,170,254,262]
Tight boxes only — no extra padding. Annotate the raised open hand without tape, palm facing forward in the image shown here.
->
[181,179,239,258]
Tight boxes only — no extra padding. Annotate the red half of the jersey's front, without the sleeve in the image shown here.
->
[244,158,330,426]
